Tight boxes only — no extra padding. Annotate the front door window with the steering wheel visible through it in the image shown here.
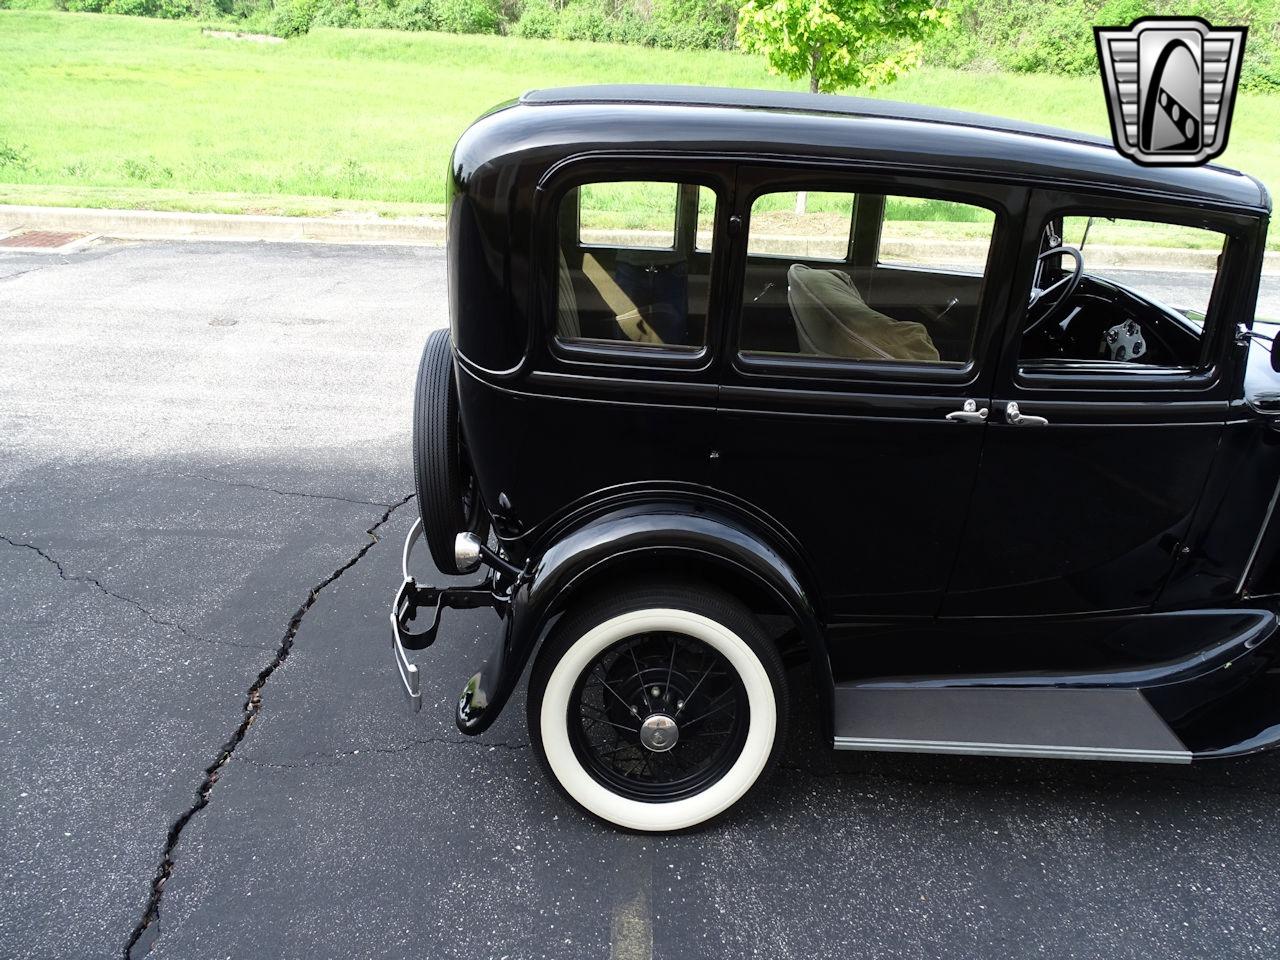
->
[1019,212,1226,372]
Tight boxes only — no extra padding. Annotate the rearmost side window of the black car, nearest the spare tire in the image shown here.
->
[554,180,716,349]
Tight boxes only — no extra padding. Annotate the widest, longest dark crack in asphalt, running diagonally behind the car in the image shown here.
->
[123,494,413,960]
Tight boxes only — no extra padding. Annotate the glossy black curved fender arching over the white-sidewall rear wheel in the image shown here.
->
[457,500,832,733]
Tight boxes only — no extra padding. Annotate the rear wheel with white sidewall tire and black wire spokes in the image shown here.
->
[527,586,787,831]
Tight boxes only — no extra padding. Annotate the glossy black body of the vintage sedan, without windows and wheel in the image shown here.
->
[399,87,1280,755]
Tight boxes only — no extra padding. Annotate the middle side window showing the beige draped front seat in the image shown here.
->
[739,192,995,365]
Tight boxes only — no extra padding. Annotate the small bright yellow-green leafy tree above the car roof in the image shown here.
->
[737,0,948,93]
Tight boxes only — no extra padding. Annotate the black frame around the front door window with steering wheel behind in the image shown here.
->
[1000,188,1256,398]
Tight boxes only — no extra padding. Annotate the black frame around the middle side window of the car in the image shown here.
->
[724,163,1027,393]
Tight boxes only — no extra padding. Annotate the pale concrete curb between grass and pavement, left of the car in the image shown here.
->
[0,205,444,247]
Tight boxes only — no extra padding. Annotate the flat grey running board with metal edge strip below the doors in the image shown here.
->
[835,684,1192,763]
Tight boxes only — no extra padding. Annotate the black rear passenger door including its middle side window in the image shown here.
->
[712,164,1025,621]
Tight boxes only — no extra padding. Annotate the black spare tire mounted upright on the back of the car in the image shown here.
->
[413,330,489,576]
